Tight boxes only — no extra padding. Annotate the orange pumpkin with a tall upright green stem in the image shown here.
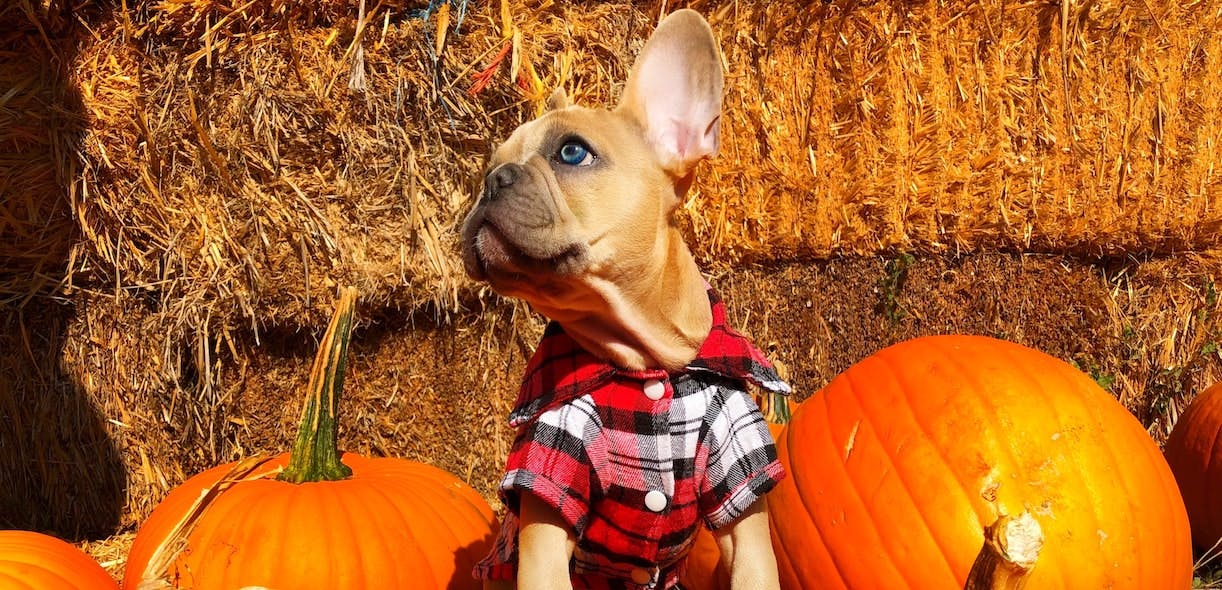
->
[123,290,495,590]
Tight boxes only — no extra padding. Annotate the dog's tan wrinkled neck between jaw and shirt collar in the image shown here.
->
[560,228,712,371]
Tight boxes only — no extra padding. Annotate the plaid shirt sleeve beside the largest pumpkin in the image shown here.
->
[700,388,785,530]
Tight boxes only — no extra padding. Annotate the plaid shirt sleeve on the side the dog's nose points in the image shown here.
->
[500,398,601,537]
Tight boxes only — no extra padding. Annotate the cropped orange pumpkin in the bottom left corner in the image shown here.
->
[0,530,119,590]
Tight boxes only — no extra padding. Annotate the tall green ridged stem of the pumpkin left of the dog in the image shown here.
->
[276,287,357,484]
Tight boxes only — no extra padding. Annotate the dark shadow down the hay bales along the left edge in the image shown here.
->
[0,0,126,540]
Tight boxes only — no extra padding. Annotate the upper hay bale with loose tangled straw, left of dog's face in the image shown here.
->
[65,2,645,331]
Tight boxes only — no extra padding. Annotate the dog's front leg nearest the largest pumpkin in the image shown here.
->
[712,500,781,590]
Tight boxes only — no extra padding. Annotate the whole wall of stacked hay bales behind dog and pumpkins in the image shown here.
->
[0,0,1222,549]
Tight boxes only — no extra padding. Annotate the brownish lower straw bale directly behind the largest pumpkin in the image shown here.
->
[714,252,1222,442]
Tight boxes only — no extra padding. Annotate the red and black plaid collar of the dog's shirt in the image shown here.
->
[510,287,789,426]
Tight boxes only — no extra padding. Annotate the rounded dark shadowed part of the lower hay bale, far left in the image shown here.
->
[0,298,127,540]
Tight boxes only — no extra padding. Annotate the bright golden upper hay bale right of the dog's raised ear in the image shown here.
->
[688,0,1222,260]
